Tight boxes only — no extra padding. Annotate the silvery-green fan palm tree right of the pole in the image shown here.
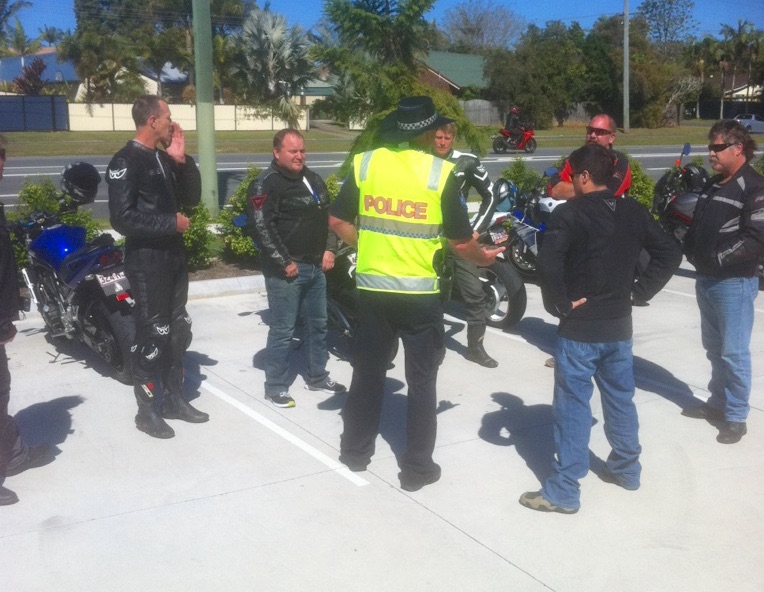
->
[240,7,313,127]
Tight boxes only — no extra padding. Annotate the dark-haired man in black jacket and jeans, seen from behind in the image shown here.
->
[520,144,682,514]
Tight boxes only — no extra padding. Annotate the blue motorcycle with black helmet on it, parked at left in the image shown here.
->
[13,162,135,384]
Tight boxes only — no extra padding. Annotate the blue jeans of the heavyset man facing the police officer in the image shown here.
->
[265,262,329,395]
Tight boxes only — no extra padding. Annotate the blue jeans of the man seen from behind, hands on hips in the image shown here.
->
[541,337,642,509]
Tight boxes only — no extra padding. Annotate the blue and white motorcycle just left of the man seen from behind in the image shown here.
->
[506,168,564,281]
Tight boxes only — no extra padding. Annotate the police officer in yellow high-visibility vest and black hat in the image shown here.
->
[329,97,503,491]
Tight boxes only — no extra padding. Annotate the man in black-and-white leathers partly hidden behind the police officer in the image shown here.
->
[433,123,499,368]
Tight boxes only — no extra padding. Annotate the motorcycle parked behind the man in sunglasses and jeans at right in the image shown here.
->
[652,143,709,244]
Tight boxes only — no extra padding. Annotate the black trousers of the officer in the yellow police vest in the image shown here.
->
[340,290,445,478]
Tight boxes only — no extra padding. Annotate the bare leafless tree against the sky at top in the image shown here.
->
[442,0,525,53]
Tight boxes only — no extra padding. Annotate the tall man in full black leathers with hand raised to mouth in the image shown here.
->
[106,95,209,438]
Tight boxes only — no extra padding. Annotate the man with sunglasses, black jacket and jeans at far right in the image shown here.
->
[682,120,764,444]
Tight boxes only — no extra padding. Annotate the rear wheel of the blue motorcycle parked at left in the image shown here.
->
[92,302,135,385]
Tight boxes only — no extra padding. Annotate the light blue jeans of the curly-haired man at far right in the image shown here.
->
[695,275,759,421]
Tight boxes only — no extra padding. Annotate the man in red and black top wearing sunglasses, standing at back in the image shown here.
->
[549,114,631,199]
